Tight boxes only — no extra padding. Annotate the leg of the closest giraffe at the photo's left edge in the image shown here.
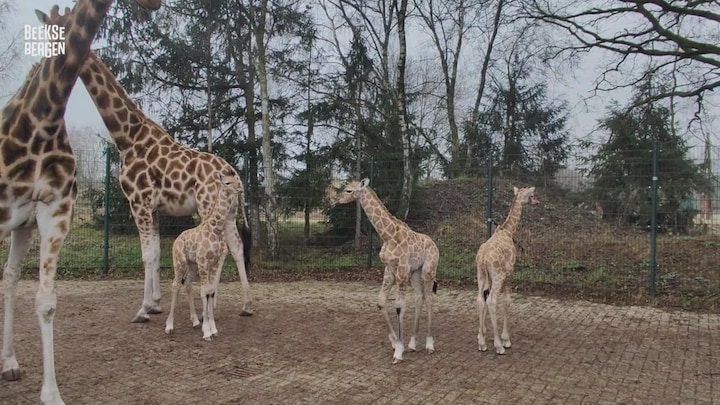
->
[2,228,34,381]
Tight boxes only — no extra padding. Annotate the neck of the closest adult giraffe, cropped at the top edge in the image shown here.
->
[18,0,113,128]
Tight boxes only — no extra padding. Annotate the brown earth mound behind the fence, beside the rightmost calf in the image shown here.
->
[408,178,720,311]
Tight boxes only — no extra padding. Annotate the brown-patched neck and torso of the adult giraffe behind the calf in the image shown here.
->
[80,52,248,226]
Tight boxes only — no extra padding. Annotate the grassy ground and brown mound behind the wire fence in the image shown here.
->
[0,175,720,311]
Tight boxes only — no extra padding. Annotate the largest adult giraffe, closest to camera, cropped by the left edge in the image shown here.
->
[0,0,160,404]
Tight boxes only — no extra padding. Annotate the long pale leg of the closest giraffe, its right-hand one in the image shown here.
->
[35,205,72,404]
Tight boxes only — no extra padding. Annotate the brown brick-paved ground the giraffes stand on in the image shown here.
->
[0,280,720,405]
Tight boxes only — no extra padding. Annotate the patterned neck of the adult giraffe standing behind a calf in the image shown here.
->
[80,52,174,155]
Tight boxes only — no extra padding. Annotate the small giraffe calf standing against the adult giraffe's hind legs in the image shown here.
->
[165,173,243,341]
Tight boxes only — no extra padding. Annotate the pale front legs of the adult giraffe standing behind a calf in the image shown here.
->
[132,208,162,323]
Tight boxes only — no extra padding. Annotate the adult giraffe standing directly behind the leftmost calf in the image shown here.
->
[80,52,252,322]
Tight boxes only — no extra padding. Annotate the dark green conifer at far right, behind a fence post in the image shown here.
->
[583,76,711,232]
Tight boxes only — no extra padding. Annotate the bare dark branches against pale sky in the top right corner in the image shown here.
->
[524,0,720,107]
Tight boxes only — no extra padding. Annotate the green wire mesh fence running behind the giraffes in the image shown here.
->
[0,146,720,306]
